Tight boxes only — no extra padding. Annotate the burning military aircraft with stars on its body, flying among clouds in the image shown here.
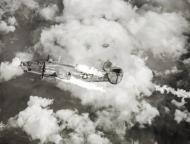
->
[20,56,123,84]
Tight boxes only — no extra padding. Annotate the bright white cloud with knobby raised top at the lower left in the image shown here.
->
[9,96,62,143]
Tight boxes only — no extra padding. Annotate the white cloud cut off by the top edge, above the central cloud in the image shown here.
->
[60,0,135,20]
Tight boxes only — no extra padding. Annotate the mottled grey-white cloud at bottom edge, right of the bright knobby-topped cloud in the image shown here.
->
[56,110,110,144]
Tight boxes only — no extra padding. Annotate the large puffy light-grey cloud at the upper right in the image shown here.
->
[126,11,189,57]
